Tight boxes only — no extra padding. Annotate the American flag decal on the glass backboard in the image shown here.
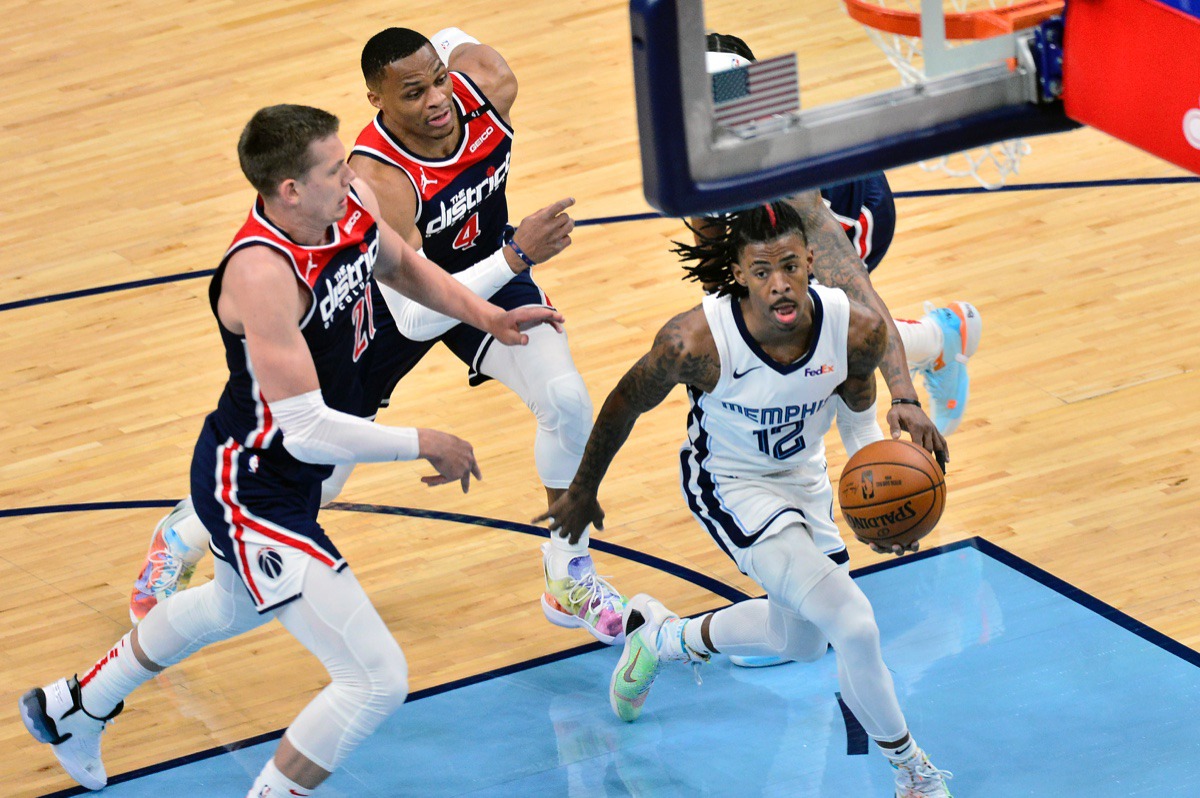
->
[712,53,800,127]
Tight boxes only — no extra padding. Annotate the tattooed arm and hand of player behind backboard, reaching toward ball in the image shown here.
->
[788,191,949,462]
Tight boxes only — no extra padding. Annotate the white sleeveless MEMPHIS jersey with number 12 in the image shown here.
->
[688,286,850,476]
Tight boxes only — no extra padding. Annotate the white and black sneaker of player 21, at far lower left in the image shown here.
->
[20,677,125,790]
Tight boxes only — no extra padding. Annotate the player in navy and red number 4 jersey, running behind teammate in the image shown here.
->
[130,28,622,643]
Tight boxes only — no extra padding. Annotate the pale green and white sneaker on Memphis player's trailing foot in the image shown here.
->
[608,593,709,722]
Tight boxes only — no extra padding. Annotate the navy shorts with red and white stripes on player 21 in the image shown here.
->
[192,418,346,612]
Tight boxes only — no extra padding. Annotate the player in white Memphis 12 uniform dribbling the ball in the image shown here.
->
[536,202,949,798]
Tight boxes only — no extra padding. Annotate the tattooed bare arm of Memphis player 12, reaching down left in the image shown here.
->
[533,307,721,544]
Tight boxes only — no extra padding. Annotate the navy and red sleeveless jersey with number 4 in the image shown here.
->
[352,72,512,274]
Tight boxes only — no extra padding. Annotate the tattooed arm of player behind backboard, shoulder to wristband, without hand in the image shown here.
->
[790,191,917,398]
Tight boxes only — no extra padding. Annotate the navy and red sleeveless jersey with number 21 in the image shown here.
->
[209,190,379,482]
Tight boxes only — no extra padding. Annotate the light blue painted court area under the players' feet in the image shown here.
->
[56,541,1200,798]
